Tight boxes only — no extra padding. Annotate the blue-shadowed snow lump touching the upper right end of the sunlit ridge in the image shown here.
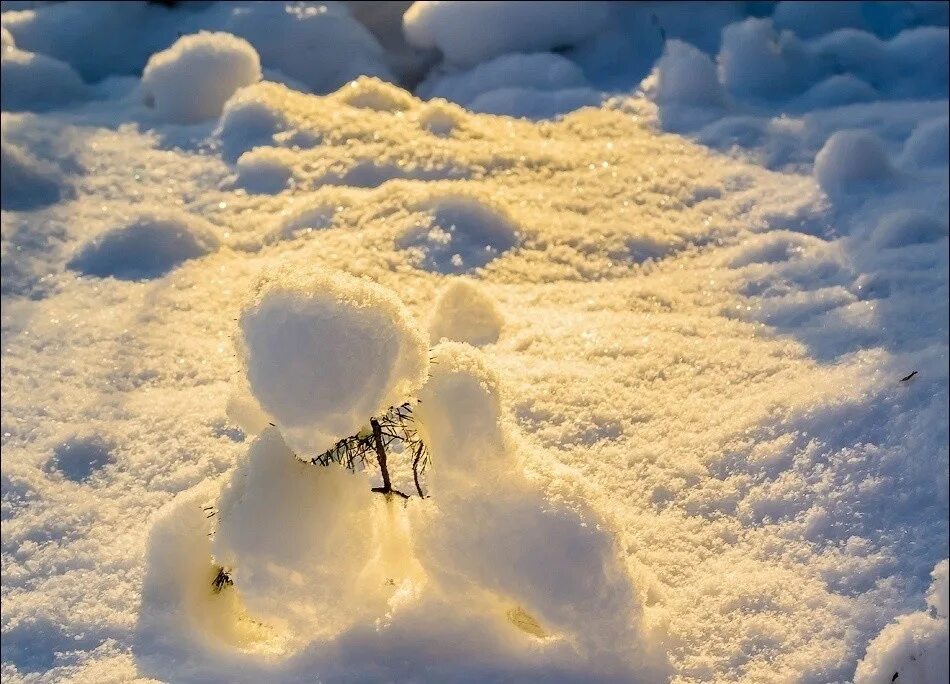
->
[654,40,723,106]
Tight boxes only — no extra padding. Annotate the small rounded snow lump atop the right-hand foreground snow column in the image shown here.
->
[429,278,504,346]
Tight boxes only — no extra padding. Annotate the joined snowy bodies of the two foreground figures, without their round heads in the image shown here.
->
[136,342,669,684]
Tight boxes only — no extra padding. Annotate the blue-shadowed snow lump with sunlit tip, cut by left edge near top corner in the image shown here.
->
[0,46,88,112]
